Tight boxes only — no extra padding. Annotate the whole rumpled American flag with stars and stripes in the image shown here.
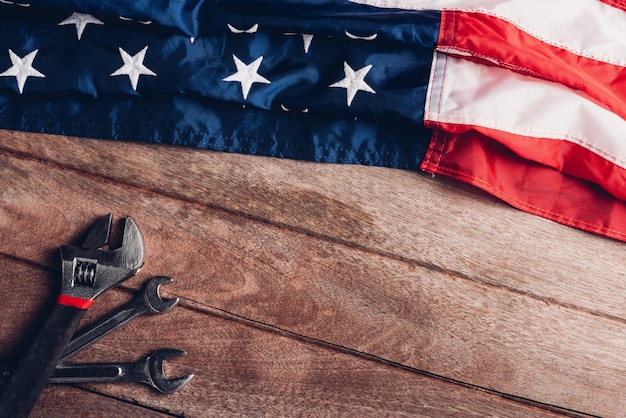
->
[0,0,626,240]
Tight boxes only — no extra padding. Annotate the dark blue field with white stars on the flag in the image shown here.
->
[0,0,439,169]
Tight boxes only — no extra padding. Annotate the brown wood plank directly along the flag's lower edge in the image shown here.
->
[0,131,626,326]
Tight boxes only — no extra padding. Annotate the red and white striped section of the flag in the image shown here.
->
[358,0,626,240]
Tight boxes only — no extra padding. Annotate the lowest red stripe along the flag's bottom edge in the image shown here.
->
[421,130,626,241]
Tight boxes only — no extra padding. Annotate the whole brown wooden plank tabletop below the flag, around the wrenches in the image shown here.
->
[0,131,626,417]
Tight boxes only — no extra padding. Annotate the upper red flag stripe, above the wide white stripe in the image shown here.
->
[437,10,626,119]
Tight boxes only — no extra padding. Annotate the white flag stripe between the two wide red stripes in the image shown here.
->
[424,52,626,168]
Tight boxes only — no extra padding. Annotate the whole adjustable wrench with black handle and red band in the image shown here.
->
[0,214,144,417]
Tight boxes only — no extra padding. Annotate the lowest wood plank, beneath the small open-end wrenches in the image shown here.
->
[0,257,562,418]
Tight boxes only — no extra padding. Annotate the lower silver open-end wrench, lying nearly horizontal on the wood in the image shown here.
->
[48,348,194,393]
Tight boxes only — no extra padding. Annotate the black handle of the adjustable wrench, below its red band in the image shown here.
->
[0,304,87,418]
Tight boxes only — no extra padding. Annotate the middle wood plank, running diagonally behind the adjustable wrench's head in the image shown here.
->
[0,149,626,416]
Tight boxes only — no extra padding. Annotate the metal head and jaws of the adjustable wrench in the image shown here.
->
[61,214,145,299]
